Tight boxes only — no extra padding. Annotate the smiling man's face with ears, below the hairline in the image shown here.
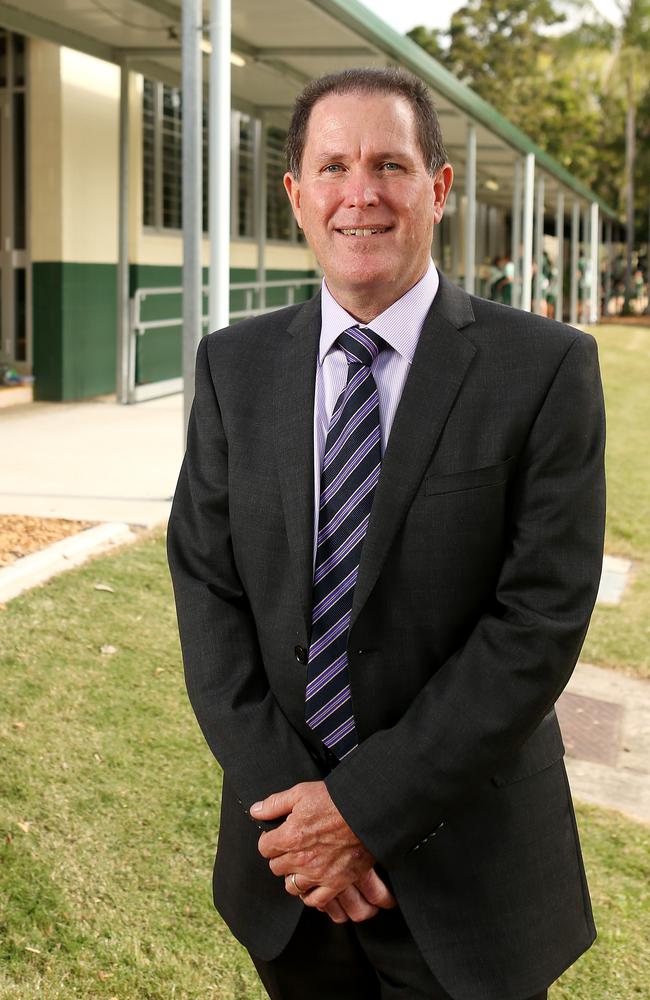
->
[284,93,453,315]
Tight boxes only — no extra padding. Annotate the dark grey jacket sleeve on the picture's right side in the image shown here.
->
[327,334,605,864]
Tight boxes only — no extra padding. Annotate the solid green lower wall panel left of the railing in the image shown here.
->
[32,261,117,400]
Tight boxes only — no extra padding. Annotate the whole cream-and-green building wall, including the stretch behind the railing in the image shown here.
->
[28,40,316,400]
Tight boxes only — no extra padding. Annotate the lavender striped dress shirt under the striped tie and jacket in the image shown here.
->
[314,261,438,559]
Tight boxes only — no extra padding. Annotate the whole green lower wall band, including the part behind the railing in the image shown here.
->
[32,262,314,400]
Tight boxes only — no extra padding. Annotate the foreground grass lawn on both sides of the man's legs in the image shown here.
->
[0,537,650,1000]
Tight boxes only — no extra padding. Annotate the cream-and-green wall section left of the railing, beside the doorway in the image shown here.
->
[28,40,119,400]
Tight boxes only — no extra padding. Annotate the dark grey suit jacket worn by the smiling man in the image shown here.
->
[169,276,604,1000]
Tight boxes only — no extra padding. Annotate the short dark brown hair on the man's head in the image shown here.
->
[285,68,447,178]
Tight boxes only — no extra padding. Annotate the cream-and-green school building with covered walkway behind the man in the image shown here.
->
[0,0,621,402]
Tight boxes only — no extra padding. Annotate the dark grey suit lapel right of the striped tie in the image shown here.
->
[352,274,476,624]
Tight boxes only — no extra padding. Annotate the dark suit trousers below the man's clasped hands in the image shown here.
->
[251,907,547,1000]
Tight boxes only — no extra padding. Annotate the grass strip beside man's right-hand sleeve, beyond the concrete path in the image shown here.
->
[582,325,650,677]
